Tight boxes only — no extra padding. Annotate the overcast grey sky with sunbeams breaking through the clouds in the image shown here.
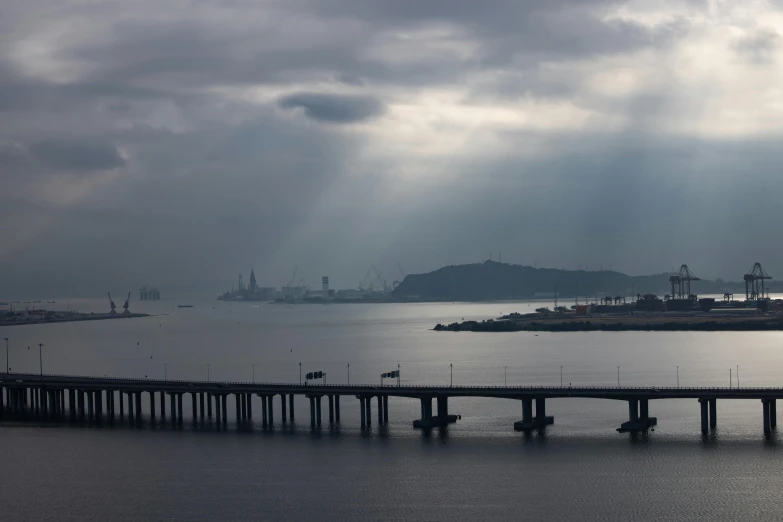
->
[0,0,783,298]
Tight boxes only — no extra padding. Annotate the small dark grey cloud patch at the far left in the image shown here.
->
[30,139,125,171]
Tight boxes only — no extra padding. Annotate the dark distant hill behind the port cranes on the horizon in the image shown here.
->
[394,261,772,301]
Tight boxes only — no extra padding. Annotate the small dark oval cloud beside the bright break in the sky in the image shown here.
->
[278,92,384,123]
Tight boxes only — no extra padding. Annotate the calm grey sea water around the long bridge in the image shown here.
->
[0,300,783,521]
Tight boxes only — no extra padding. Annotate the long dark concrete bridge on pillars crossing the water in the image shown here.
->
[0,373,783,437]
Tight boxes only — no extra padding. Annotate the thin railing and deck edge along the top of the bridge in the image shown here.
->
[0,373,783,393]
